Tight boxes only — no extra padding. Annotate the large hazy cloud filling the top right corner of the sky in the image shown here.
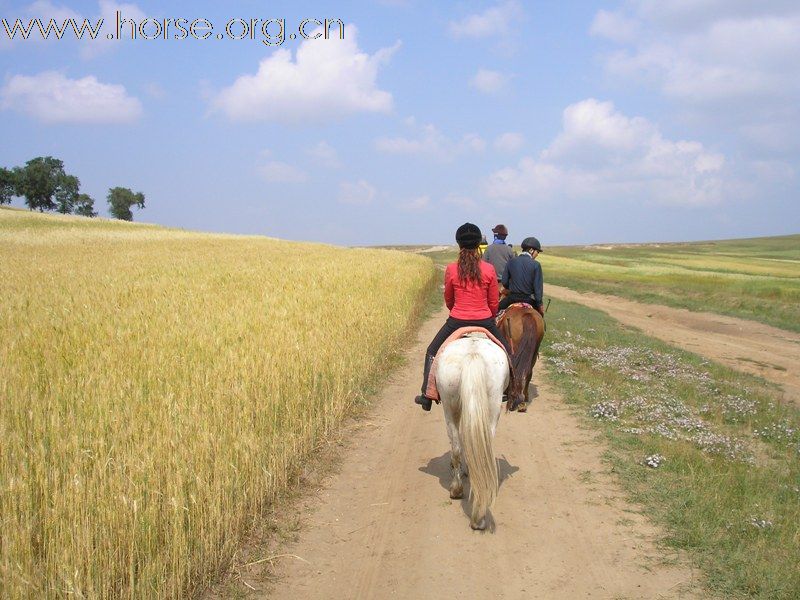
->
[592,0,800,155]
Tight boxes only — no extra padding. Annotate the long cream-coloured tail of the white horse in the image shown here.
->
[459,351,498,523]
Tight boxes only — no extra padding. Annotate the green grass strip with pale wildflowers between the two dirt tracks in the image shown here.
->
[543,302,800,599]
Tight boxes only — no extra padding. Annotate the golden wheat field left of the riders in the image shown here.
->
[0,209,433,598]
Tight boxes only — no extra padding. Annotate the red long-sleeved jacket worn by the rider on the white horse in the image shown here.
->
[444,261,500,321]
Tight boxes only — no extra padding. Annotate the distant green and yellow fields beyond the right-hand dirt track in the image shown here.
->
[423,235,800,331]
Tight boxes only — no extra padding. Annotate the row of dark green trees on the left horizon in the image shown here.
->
[0,156,144,221]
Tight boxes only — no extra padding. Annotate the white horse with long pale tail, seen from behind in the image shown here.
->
[436,333,508,529]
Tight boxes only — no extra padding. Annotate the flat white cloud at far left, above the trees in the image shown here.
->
[0,71,142,123]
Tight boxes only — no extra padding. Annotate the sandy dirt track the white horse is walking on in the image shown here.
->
[234,312,698,600]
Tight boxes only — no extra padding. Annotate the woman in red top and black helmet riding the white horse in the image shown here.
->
[414,223,511,410]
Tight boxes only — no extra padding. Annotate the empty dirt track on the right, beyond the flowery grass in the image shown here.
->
[545,284,800,404]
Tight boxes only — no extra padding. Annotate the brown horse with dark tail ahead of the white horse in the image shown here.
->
[497,304,545,412]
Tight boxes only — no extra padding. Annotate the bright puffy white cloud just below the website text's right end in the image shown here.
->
[211,25,399,123]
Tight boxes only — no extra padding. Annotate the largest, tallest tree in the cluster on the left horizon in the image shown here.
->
[14,156,80,212]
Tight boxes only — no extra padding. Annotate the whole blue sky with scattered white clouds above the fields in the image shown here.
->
[0,0,800,246]
